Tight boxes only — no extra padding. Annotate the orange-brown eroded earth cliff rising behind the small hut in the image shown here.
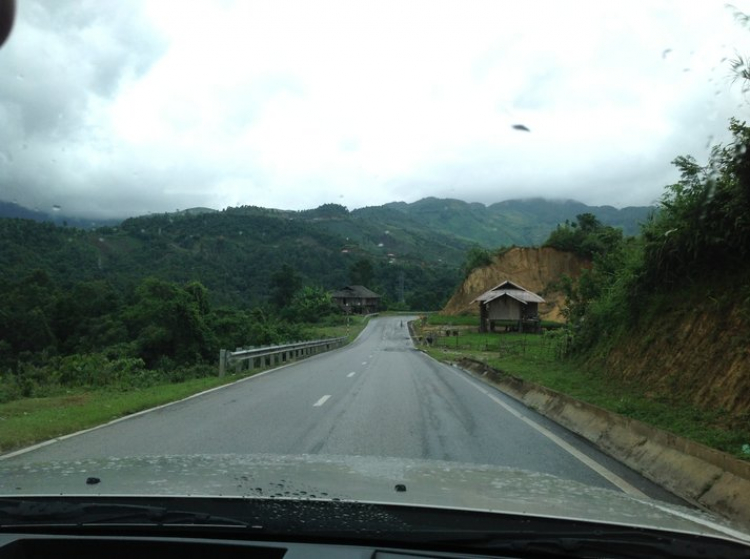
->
[443,247,590,322]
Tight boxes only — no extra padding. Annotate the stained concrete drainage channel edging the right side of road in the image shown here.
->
[456,358,750,527]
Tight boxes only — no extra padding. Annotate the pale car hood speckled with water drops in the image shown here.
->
[0,454,750,541]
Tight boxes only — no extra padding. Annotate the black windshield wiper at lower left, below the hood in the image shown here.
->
[0,500,249,528]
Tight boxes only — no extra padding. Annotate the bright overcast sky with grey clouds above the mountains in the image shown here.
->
[0,0,750,218]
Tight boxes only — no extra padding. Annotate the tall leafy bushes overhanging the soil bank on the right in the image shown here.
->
[560,120,750,353]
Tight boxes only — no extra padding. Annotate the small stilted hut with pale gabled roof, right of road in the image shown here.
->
[472,280,545,332]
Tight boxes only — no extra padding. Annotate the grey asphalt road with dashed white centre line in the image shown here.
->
[6,317,682,503]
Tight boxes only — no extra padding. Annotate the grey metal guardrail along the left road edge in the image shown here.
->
[219,336,346,377]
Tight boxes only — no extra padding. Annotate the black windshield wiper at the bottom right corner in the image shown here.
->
[420,529,750,559]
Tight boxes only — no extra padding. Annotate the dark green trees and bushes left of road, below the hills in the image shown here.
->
[0,270,318,401]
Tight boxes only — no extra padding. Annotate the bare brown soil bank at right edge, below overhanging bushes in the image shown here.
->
[604,274,750,422]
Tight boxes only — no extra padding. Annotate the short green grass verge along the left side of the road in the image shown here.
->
[0,316,368,453]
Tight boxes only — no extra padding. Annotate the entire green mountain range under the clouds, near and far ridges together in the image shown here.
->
[0,198,651,309]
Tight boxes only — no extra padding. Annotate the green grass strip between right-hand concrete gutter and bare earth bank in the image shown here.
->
[422,324,750,460]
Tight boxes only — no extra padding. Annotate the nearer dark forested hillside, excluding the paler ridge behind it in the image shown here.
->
[0,205,467,309]
